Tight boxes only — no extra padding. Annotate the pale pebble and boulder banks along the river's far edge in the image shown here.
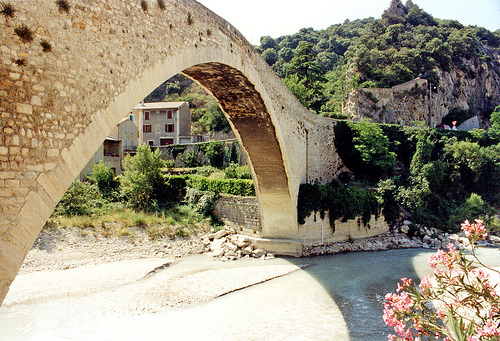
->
[19,221,500,274]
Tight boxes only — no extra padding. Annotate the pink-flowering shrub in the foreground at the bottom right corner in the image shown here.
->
[384,220,500,341]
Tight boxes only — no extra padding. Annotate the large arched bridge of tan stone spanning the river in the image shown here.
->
[0,0,337,302]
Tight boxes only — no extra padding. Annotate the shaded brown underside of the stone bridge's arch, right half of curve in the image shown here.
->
[183,63,293,237]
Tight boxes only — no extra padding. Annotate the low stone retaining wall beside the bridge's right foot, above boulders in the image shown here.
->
[214,195,262,237]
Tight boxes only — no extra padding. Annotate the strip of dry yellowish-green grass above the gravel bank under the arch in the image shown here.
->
[44,205,211,239]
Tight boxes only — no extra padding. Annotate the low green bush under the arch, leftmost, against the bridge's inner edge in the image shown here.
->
[55,181,106,216]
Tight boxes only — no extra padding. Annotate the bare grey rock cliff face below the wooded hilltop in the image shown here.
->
[343,49,500,128]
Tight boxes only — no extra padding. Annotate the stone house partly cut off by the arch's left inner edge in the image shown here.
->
[79,115,139,181]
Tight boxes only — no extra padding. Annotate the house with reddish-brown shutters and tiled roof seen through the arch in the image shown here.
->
[132,102,192,147]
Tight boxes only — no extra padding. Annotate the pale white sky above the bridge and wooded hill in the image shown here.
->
[197,0,500,45]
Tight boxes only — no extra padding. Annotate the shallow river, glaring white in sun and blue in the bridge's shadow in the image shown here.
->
[0,249,500,341]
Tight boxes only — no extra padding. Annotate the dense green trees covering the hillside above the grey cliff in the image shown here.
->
[257,0,500,117]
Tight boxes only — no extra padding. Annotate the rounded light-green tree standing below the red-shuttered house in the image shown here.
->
[120,144,168,209]
